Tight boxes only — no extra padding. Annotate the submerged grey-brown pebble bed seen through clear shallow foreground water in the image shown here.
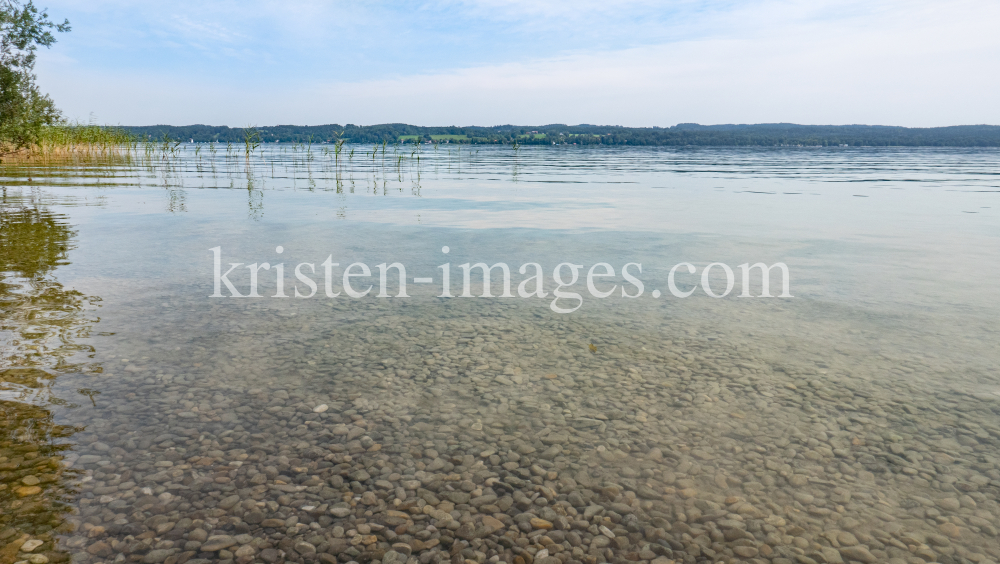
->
[0,301,1000,564]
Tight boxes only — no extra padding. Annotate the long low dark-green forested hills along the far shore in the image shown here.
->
[124,123,1000,147]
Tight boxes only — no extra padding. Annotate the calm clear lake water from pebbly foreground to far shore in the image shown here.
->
[0,145,1000,564]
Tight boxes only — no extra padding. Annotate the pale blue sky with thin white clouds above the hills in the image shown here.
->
[36,0,1000,127]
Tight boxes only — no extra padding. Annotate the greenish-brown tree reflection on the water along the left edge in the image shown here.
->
[0,193,100,562]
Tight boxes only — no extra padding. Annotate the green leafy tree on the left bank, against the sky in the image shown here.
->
[0,0,70,151]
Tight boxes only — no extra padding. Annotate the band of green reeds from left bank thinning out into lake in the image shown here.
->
[0,123,492,197]
